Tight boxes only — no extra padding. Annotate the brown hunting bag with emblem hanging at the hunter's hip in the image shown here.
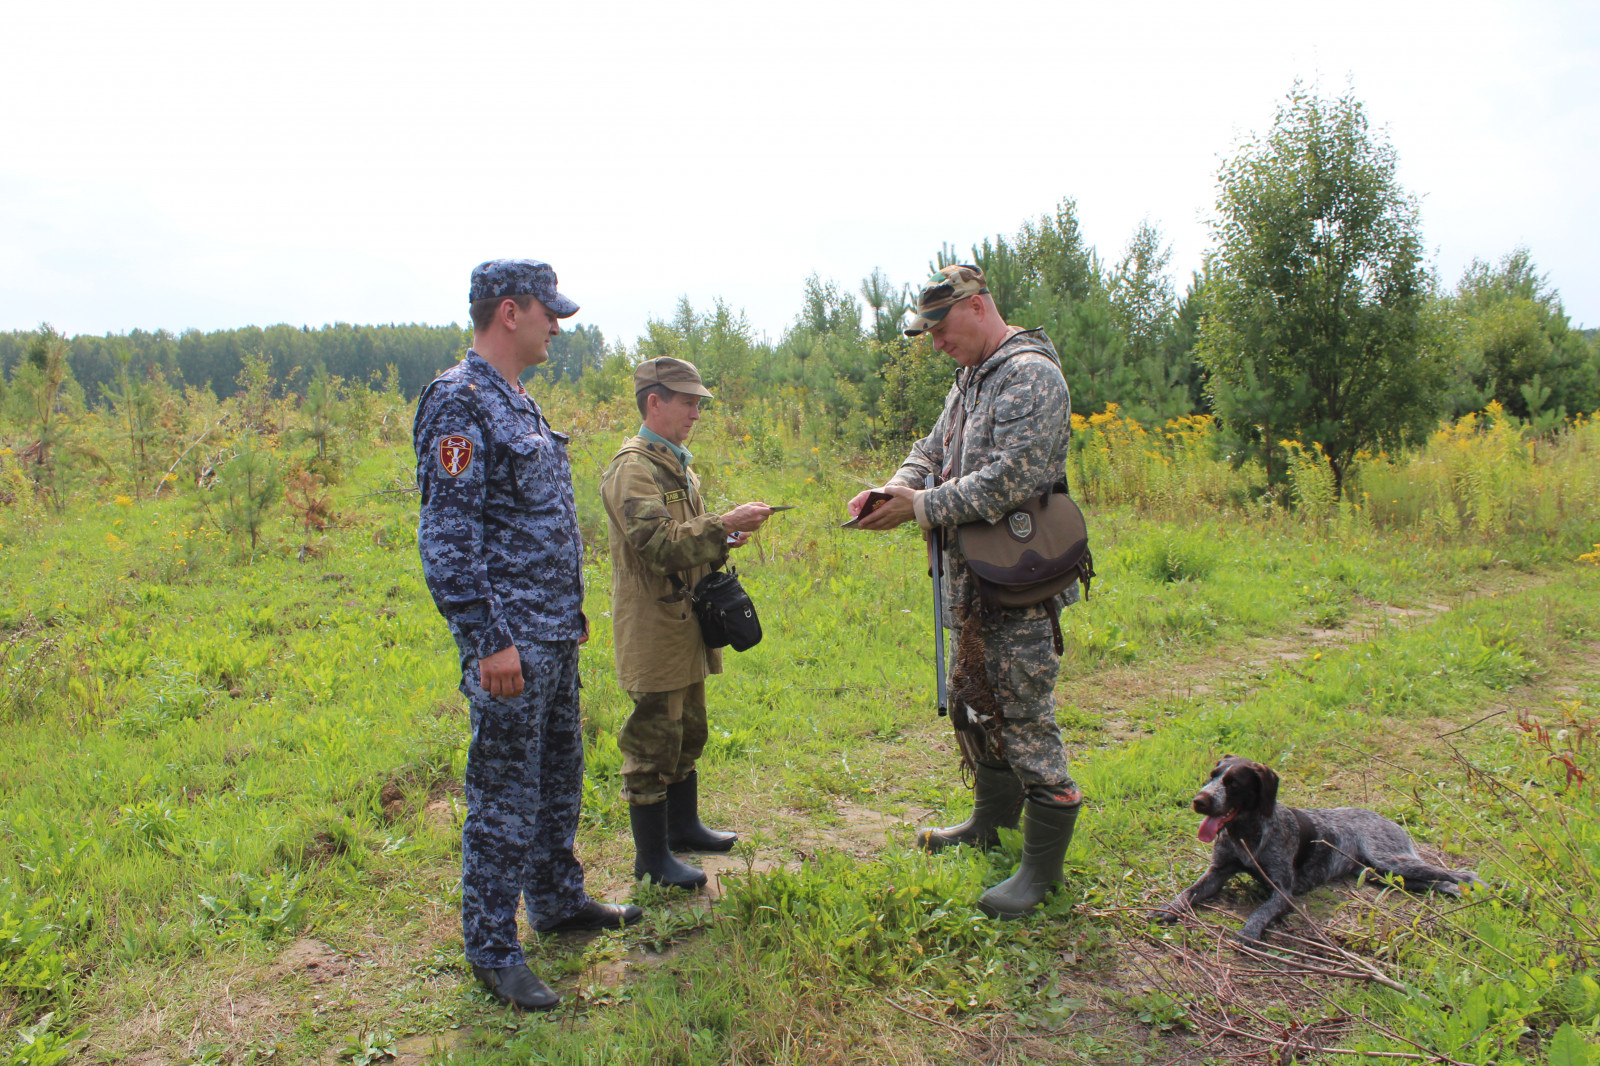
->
[955,482,1094,607]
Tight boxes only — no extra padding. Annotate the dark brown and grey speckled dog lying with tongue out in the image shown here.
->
[1150,755,1482,940]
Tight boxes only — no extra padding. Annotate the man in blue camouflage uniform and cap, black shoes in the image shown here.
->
[413,259,640,1010]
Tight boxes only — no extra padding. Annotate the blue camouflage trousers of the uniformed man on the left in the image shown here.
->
[461,640,587,967]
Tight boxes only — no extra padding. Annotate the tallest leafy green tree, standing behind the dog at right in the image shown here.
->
[1200,85,1445,491]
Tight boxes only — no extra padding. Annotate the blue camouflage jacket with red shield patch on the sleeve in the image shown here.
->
[413,351,584,658]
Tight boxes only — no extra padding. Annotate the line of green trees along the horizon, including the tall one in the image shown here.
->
[0,85,1600,499]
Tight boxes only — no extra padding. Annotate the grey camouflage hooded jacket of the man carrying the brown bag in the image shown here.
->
[890,330,1078,610]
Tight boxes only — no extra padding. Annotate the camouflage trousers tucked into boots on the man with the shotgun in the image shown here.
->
[952,599,1077,805]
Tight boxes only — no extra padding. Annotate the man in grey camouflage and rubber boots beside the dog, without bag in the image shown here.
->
[850,266,1083,919]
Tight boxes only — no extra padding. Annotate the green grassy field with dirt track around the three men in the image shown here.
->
[0,398,1600,1066]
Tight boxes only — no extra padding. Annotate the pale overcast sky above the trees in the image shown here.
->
[0,0,1600,341]
